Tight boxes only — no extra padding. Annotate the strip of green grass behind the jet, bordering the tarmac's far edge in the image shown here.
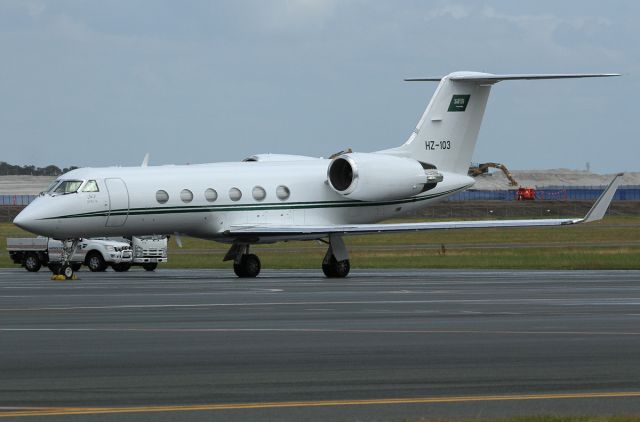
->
[0,217,640,269]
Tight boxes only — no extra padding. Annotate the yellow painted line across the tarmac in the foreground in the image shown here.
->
[0,391,640,418]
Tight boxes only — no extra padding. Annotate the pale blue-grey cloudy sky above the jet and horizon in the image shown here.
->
[0,0,640,173]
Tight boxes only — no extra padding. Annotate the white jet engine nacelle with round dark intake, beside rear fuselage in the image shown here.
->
[327,153,430,201]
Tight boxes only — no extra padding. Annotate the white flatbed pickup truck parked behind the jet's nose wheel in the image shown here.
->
[7,237,133,272]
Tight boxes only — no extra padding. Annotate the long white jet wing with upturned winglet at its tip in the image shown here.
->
[225,173,623,237]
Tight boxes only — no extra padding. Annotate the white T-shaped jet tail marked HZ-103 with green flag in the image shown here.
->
[380,72,618,175]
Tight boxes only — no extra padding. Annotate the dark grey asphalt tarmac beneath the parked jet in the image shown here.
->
[0,269,640,421]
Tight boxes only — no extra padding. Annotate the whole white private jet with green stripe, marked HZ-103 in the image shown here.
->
[14,72,619,278]
